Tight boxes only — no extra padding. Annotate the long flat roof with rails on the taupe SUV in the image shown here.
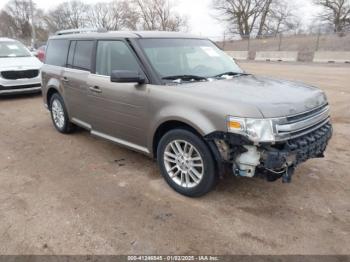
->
[50,31,205,39]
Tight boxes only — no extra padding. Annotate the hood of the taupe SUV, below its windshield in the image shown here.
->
[182,75,327,118]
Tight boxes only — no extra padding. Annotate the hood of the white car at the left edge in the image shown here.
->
[0,56,42,71]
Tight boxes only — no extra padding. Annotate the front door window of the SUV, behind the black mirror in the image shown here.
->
[96,41,141,76]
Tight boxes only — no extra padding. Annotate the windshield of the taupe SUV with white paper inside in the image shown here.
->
[139,39,243,78]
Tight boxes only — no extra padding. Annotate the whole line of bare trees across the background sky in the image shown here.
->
[0,0,350,42]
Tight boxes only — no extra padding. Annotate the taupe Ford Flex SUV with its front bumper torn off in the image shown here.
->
[42,32,332,197]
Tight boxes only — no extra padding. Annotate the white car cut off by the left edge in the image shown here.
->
[0,38,42,95]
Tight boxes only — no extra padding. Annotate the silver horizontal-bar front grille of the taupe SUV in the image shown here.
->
[274,105,330,141]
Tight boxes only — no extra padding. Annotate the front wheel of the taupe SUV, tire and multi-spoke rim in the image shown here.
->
[157,129,217,197]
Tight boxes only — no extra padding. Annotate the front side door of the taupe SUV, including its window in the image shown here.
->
[88,40,148,152]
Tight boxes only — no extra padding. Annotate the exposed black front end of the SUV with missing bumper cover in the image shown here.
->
[206,122,332,183]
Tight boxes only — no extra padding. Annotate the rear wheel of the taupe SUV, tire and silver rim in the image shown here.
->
[50,93,74,134]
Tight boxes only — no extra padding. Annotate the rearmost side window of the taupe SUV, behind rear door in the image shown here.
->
[45,40,69,66]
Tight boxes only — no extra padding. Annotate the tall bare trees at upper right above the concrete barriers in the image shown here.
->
[212,0,350,39]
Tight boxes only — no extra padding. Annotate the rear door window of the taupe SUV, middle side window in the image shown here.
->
[73,41,94,71]
